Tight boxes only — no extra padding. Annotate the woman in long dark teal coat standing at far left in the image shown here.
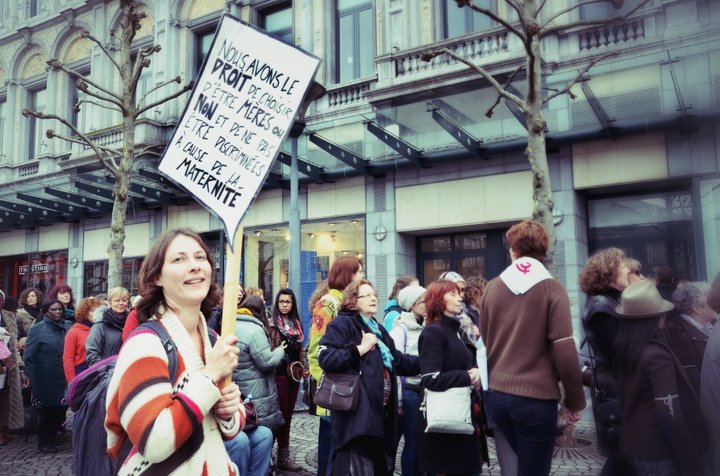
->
[23,299,72,453]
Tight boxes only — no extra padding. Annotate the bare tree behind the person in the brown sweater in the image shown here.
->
[423,0,650,275]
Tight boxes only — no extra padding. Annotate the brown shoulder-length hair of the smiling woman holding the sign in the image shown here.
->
[137,228,220,323]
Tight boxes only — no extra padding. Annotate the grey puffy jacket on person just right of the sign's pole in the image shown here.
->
[233,309,285,430]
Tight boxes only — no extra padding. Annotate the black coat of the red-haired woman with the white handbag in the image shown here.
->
[418,317,485,473]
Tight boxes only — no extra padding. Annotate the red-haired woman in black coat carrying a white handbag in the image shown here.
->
[418,279,488,474]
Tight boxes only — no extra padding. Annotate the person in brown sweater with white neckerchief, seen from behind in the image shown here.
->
[480,220,585,475]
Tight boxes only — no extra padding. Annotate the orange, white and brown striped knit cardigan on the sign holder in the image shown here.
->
[105,311,245,475]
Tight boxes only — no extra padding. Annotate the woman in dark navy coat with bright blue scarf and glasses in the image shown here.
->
[318,279,420,476]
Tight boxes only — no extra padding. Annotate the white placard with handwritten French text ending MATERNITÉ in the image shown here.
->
[163,14,320,243]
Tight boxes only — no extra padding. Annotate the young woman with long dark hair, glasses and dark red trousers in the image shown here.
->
[269,288,305,472]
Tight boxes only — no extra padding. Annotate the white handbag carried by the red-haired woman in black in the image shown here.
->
[420,387,475,435]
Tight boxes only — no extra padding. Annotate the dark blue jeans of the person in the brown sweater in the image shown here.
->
[485,390,558,476]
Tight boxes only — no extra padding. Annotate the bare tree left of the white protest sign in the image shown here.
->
[22,0,193,288]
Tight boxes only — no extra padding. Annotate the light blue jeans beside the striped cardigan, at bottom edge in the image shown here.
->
[225,426,273,476]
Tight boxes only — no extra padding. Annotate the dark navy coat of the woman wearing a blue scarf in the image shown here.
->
[318,311,420,470]
